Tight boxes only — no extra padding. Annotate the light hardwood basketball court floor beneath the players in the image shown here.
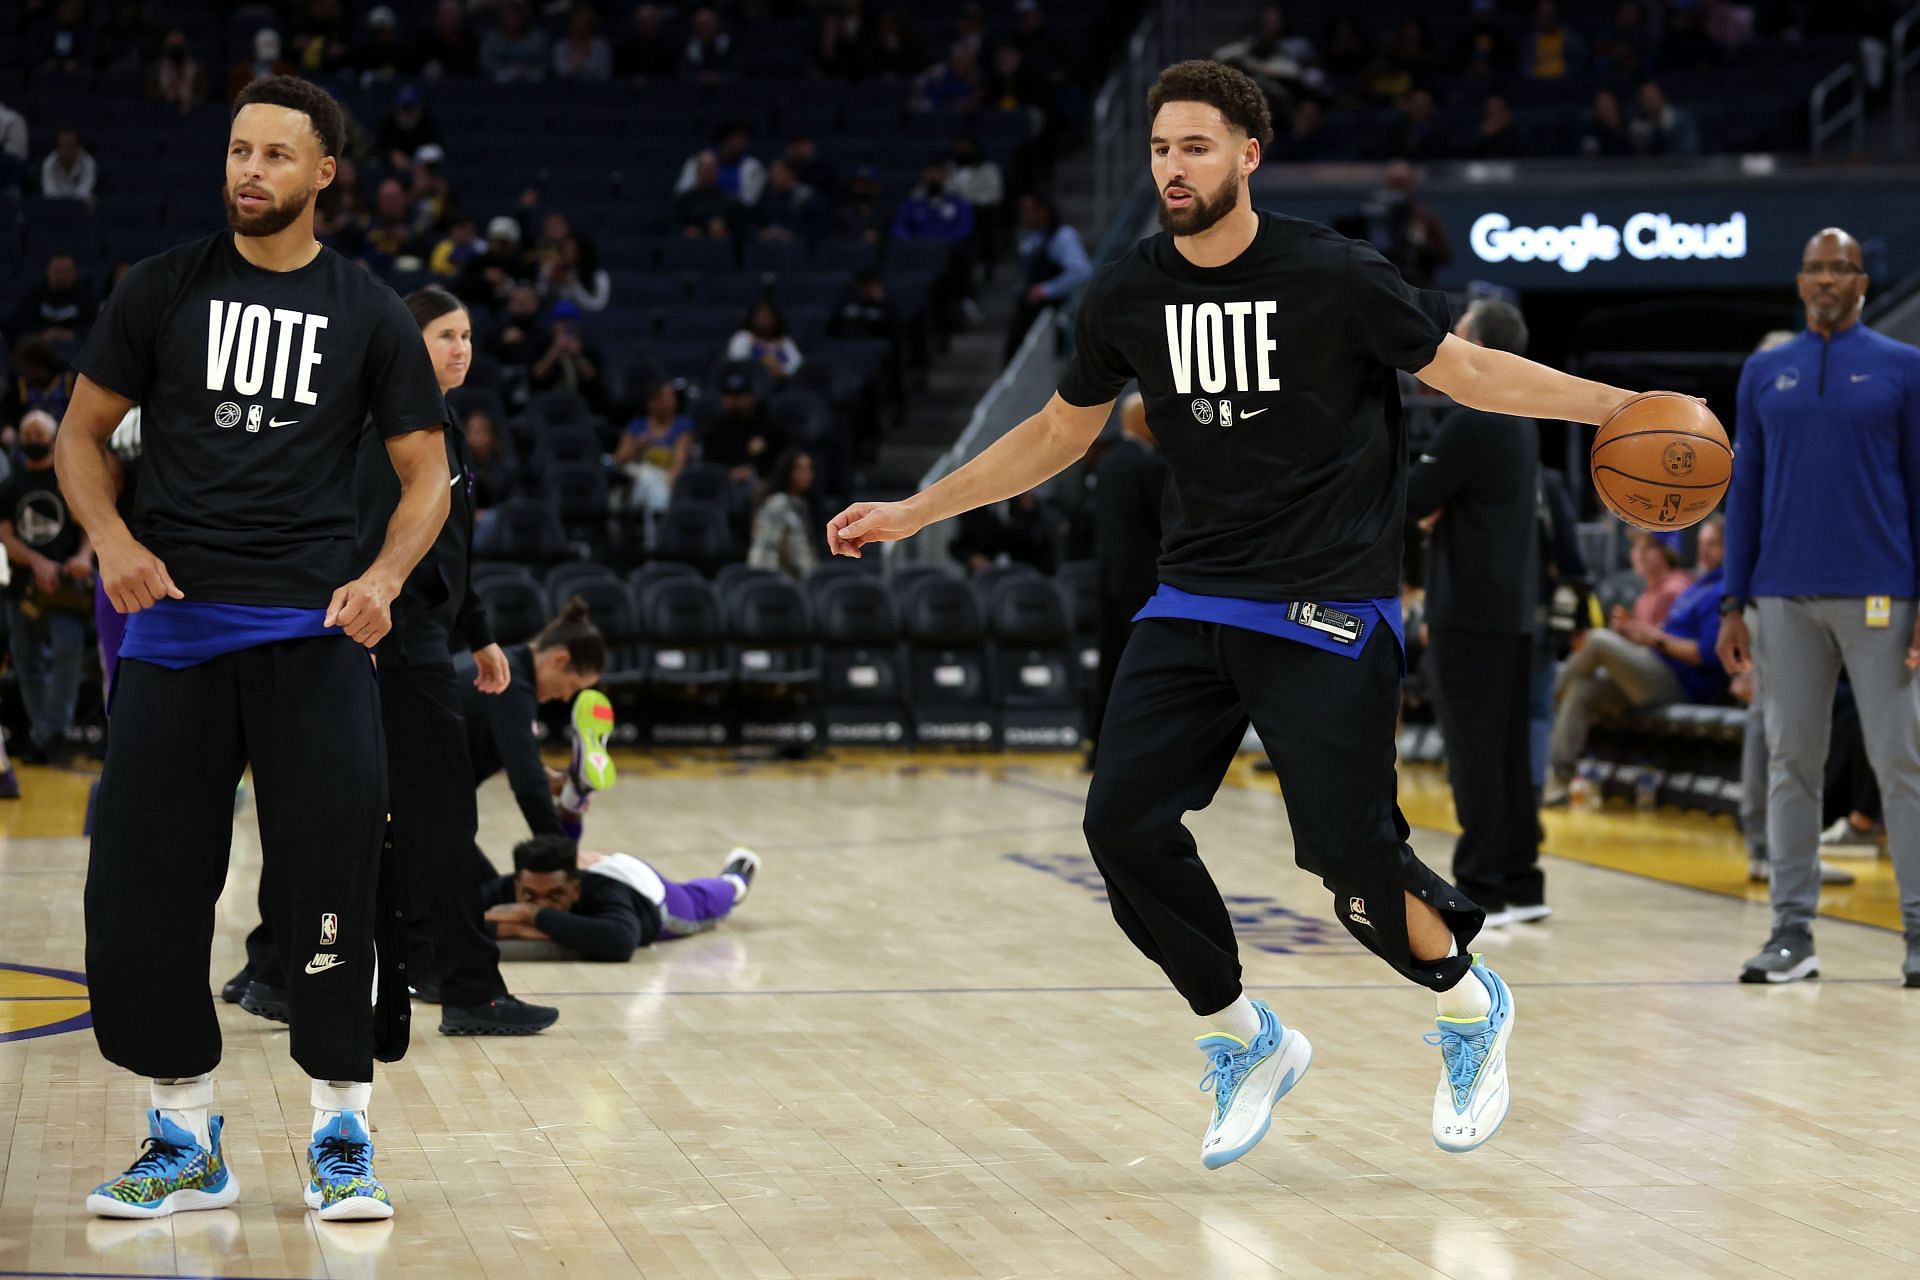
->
[0,756,1920,1280]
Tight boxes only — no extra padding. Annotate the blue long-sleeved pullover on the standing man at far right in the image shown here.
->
[1726,324,1920,599]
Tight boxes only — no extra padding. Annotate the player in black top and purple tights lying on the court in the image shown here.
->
[480,835,760,961]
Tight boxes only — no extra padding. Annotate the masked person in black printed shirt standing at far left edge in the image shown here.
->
[0,409,94,764]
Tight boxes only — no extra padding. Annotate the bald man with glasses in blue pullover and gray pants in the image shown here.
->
[1718,226,1920,986]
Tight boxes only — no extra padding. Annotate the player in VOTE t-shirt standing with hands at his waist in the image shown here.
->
[58,77,447,1221]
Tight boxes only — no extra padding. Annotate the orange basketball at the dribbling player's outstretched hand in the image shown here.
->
[1592,391,1734,530]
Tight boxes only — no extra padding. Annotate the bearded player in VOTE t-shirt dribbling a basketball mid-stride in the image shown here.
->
[828,61,1666,1169]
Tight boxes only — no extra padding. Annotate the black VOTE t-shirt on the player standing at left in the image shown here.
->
[79,232,442,608]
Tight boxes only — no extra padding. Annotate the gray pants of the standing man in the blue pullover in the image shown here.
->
[1753,595,1920,942]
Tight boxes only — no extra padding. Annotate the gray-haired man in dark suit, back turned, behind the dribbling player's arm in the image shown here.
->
[1407,297,1548,923]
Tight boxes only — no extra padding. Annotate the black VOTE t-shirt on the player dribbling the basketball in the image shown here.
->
[1060,213,1450,601]
